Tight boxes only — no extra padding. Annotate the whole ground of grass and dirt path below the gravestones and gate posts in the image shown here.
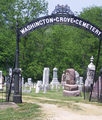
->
[0,87,102,120]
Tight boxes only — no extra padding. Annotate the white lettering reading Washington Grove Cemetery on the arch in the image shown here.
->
[20,16,102,37]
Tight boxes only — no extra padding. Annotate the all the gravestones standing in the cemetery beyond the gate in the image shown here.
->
[0,56,101,97]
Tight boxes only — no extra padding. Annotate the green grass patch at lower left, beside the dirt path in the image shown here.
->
[0,103,41,120]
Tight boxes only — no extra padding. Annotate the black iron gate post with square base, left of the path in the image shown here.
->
[13,20,22,103]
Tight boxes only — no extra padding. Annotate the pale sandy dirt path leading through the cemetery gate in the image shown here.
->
[23,98,102,120]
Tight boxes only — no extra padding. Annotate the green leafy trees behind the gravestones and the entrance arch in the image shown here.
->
[0,0,102,81]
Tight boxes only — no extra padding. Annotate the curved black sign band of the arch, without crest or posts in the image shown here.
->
[20,5,102,39]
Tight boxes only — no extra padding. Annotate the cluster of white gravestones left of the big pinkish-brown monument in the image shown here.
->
[22,68,60,93]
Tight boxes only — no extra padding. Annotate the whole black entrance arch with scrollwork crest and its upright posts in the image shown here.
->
[14,5,102,101]
